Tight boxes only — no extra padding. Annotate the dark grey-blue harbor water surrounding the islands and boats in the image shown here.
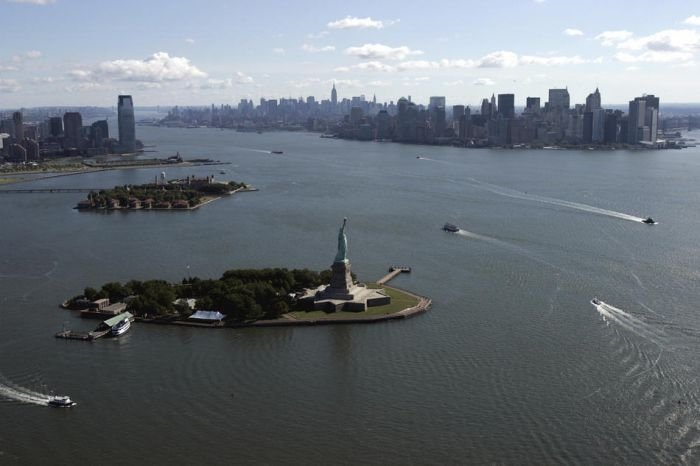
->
[0,127,700,464]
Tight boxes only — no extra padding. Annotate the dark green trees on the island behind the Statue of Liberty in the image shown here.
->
[69,268,331,322]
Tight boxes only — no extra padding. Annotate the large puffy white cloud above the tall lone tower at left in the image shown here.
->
[95,52,207,82]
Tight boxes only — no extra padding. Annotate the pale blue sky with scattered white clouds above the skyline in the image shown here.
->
[0,0,700,109]
